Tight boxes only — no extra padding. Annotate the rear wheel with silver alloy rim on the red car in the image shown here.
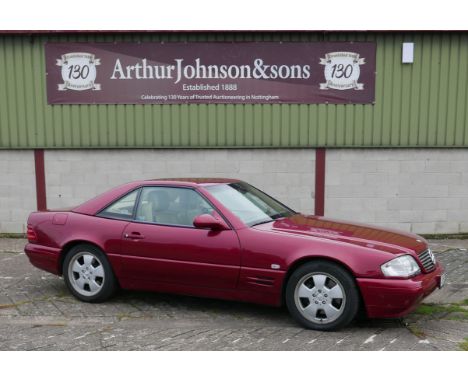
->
[62,244,116,302]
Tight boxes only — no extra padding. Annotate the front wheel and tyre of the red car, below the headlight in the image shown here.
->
[285,260,360,330]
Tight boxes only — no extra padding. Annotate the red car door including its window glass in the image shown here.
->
[117,186,240,289]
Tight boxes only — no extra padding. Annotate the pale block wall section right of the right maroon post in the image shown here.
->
[325,149,468,233]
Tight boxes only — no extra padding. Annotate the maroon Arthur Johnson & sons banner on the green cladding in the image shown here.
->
[45,42,376,104]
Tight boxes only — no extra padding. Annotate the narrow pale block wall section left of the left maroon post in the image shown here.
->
[0,150,36,233]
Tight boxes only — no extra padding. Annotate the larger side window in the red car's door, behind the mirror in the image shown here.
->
[136,187,213,227]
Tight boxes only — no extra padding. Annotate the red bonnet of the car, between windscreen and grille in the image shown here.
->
[255,214,427,254]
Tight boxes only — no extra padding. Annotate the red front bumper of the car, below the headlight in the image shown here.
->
[357,263,444,318]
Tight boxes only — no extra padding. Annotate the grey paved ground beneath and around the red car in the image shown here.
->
[0,239,468,350]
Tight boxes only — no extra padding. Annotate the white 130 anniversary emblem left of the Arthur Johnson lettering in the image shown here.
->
[57,52,101,91]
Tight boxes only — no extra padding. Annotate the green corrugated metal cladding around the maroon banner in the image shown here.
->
[0,32,468,148]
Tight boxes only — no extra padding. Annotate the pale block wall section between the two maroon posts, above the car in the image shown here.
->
[45,149,315,213]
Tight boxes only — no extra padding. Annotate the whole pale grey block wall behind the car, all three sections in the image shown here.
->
[0,149,468,233]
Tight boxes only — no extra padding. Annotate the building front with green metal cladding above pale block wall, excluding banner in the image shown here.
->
[0,32,468,234]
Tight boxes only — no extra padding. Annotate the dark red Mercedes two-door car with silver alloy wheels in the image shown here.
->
[25,178,445,331]
